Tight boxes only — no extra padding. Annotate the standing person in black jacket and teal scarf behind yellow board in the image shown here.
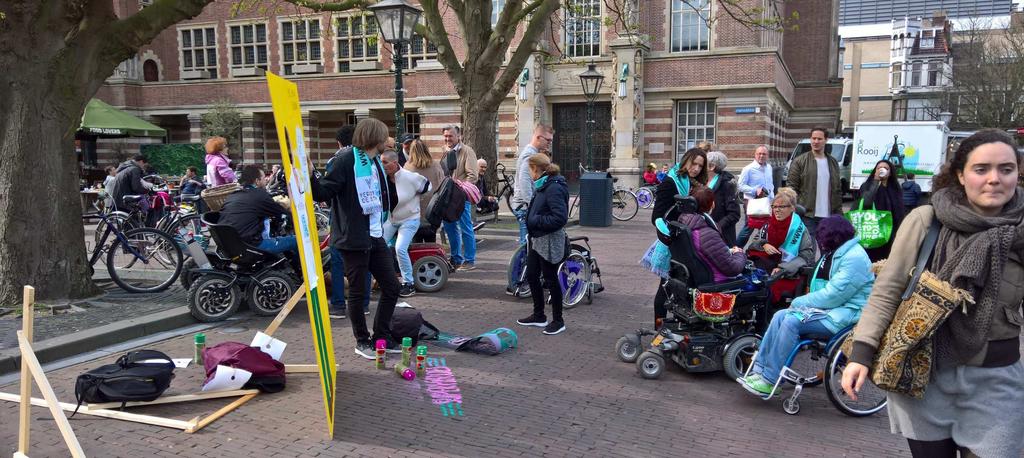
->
[310,118,399,360]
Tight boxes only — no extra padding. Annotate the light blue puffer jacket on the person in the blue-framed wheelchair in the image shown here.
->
[791,237,874,333]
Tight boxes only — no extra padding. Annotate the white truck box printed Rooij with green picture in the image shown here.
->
[850,121,949,193]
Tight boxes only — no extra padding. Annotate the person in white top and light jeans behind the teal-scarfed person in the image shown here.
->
[381,150,431,297]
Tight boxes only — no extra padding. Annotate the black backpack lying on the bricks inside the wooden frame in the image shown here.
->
[72,349,174,415]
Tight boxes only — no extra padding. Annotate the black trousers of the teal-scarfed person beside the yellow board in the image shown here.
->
[339,238,398,344]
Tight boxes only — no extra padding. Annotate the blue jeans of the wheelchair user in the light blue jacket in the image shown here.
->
[753,309,833,383]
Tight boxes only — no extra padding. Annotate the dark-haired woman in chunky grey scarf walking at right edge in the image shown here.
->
[843,129,1024,457]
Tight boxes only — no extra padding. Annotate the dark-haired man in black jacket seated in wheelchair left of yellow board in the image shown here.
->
[220,165,298,254]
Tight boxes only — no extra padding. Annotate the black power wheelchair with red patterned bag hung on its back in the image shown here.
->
[615,196,798,379]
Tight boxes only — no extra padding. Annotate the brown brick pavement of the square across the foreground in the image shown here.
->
[0,211,908,458]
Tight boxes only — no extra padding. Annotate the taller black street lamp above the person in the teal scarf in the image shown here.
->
[367,0,423,138]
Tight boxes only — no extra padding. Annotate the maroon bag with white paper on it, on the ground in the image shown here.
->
[203,342,285,392]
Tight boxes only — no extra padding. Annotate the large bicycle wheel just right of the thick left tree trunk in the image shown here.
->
[106,227,184,293]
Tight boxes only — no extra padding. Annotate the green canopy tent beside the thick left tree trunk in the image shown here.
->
[75,98,167,165]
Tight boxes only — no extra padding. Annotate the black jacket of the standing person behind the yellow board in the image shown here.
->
[309,148,398,251]
